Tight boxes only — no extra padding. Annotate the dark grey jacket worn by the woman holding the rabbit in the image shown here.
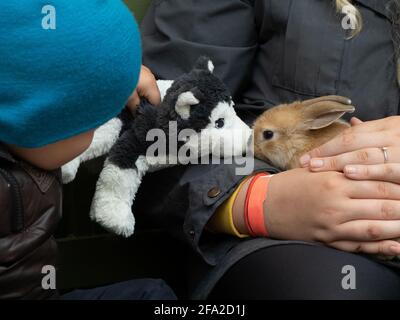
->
[137,0,400,298]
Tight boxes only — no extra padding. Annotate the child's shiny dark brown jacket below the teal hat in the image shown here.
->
[0,144,62,299]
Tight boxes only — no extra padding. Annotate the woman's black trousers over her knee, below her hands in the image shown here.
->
[209,244,400,300]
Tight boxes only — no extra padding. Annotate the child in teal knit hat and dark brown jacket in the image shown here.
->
[0,0,173,299]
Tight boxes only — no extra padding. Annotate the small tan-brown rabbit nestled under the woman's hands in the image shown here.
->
[253,96,355,170]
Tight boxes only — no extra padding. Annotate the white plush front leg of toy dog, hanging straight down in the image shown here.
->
[90,156,148,237]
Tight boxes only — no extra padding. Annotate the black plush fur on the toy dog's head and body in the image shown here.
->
[108,57,231,169]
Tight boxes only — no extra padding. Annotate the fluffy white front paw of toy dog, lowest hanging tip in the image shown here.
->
[90,194,135,238]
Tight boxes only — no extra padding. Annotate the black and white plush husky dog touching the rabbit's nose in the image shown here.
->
[62,57,252,237]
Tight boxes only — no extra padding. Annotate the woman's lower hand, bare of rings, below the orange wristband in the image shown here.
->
[264,168,400,256]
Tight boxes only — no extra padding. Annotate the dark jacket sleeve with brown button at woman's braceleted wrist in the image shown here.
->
[133,160,279,265]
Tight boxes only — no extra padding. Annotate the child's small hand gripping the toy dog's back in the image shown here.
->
[126,65,161,112]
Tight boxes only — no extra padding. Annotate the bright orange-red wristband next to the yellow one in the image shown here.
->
[245,173,271,237]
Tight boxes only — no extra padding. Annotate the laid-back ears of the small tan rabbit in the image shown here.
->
[301,96,355,130]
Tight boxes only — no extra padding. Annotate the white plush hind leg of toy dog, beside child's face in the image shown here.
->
[61,118,122,184]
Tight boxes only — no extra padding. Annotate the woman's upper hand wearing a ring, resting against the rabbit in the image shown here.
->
[300,116,400,172]
